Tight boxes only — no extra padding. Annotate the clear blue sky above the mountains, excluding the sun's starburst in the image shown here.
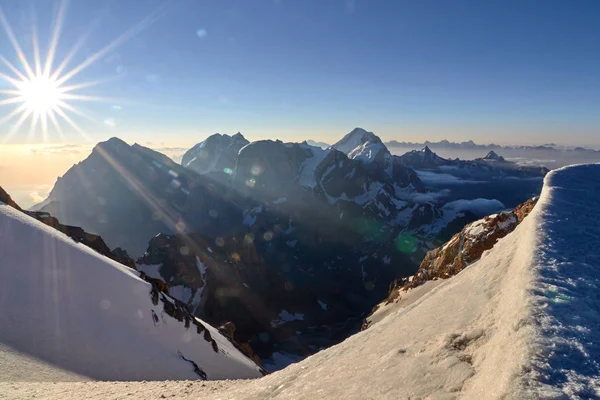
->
[0,0,600,145]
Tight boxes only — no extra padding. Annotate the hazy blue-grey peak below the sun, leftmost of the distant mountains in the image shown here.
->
[40,138,243,255]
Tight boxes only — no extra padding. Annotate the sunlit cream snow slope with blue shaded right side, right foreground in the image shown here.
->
[0,165,600,399]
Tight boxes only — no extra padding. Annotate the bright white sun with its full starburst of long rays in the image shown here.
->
[0,1,165,143]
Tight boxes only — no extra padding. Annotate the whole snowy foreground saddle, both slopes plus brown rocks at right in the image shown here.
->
[0,165,600,400]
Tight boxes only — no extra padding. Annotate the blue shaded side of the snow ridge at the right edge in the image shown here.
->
[524,164,600,399]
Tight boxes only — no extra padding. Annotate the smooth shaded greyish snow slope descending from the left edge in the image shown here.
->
[0,204,261,381]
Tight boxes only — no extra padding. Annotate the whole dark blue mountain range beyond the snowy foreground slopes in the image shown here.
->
[27,128,547,369]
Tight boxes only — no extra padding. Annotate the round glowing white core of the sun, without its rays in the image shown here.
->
[17,76,64,118]
